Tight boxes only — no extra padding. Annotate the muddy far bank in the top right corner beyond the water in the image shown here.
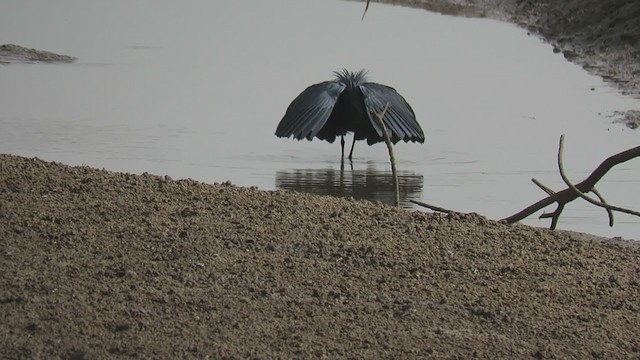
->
[363,0,640,97]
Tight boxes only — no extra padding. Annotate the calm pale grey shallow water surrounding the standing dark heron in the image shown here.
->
[0,0,640,239]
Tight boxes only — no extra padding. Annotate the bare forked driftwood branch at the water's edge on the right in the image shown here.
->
[502,135,640,229]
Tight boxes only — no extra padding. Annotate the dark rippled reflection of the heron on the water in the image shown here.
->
[276,162,424,208]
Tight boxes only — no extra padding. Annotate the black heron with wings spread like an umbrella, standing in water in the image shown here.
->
[276,69,424,160]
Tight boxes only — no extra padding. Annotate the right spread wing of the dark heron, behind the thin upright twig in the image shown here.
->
[360,83,424,143]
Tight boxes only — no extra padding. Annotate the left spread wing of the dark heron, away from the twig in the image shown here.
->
[276,81,345,140]
